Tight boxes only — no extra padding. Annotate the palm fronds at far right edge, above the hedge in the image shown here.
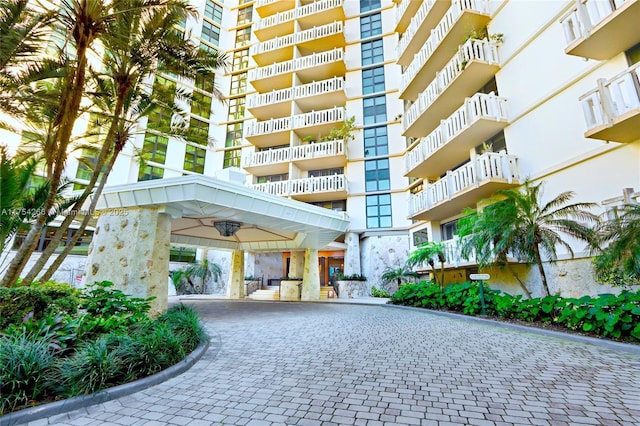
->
[593,204,640,286]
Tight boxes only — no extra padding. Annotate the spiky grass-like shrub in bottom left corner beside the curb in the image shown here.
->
[0,334,55,414]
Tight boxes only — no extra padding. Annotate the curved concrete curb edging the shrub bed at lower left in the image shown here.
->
[0,337,209,426]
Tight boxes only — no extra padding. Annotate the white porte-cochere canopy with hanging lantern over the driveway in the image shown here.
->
[96,176,349,251]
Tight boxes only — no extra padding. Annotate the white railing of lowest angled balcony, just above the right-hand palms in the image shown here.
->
[409,151,519,215]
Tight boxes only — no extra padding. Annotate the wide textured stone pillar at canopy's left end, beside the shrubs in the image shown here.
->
[85,208,171,315]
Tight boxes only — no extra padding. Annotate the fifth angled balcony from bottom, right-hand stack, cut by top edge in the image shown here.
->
[396,0,451,66]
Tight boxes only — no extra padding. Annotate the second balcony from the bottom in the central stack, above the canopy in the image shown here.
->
[242,140,347,175]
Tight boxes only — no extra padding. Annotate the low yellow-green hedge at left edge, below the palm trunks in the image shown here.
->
[0,281,79,330]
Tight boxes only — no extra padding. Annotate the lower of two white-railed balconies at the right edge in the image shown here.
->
[580,63,640,142]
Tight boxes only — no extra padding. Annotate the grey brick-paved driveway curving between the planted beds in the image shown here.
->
[21,301,640,426]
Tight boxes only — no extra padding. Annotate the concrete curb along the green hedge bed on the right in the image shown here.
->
[382,304,640,355]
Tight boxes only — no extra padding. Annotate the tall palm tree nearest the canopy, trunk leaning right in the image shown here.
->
[23,0,227,282]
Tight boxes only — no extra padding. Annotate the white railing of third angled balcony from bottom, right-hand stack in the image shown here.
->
[402,39,499,131]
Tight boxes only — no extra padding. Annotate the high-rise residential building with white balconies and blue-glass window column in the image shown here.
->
[6,0,640,292]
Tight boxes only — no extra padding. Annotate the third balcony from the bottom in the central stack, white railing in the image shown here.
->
[244,107,345,148]
